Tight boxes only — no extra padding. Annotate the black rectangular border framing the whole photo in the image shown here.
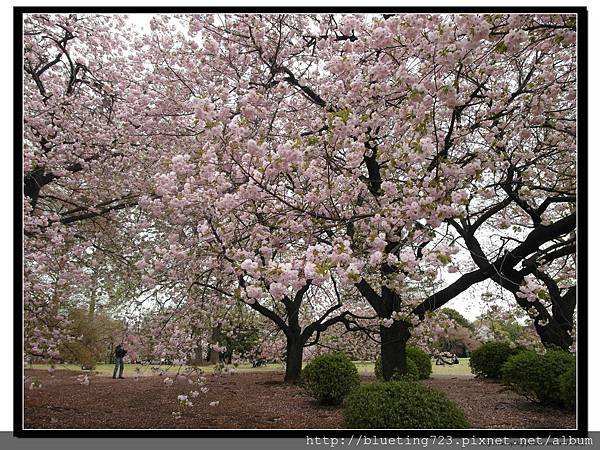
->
[13,6,589,439]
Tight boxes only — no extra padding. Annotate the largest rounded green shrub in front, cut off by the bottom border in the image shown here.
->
[342,381,469,428]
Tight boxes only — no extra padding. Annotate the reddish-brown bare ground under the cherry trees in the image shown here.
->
[24,370,575,428]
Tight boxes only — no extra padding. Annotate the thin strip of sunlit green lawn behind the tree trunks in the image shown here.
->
[27,358,471,376]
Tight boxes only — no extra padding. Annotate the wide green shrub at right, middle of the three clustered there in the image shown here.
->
[502,350,575,406]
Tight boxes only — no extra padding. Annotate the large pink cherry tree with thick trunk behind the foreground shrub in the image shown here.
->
[136,15,575,377]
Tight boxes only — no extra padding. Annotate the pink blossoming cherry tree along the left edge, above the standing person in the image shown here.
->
[23,14,207,356]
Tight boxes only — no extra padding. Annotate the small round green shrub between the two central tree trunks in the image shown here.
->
[300,353,360,405]
